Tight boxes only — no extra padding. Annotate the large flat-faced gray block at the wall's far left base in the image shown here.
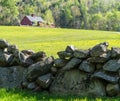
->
[0,66,26,88]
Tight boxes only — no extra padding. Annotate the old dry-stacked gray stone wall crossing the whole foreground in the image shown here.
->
[0,39,120,96]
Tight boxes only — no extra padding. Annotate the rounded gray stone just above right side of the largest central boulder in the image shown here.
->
[79,60,95,73]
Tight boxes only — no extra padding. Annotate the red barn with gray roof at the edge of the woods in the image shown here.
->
[20,14,45,26]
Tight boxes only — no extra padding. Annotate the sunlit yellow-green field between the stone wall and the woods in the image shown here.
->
[0,26,120,56]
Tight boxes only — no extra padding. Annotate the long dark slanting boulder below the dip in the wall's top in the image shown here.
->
[27,57,54,81]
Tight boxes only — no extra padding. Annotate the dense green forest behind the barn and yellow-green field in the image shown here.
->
[0,0,120,31]
